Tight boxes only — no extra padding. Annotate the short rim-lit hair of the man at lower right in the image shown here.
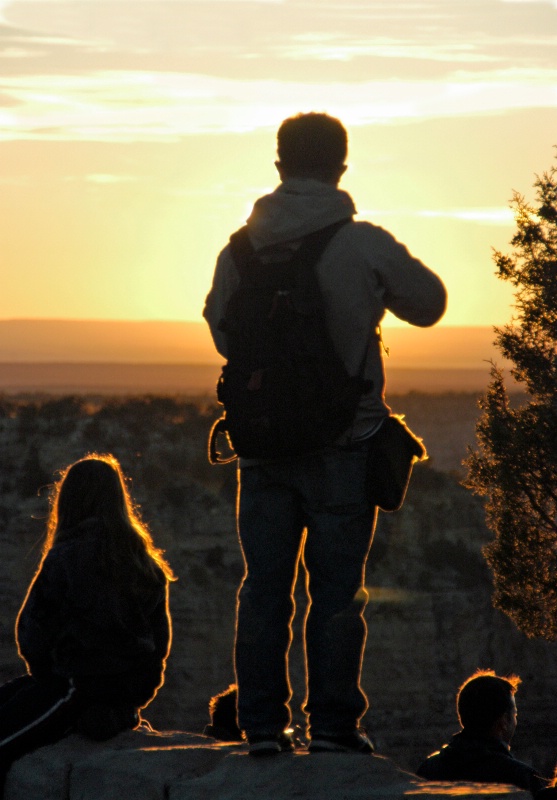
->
[456,670,520,733]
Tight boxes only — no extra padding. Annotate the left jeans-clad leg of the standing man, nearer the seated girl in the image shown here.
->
[235,465,304,738]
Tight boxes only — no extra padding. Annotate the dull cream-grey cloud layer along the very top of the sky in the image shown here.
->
[0,0,556,80]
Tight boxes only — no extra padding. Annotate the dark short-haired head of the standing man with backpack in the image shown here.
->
[275,112,348,185]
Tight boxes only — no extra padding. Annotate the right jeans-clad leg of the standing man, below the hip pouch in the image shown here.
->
[304,446,376,736]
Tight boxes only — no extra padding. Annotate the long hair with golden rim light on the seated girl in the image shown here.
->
[43,453,176,591]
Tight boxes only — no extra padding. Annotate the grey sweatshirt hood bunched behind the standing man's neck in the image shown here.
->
[247,178,356,250]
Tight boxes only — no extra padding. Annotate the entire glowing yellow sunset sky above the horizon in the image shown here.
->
[0,0,557,325]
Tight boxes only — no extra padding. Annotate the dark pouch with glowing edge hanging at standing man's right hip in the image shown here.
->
[366,414,427,511]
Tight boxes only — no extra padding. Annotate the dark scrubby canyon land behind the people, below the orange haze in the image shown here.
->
[0,384,557,772]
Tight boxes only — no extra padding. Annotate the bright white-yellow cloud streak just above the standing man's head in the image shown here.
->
[0,69,557,141]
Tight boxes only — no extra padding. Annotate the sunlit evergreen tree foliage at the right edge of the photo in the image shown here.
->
[466,156,557,639]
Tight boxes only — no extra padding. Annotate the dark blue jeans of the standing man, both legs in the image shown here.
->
[235,443,376,736]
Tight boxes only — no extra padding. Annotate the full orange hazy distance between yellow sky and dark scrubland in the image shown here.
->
[0,320,515,396]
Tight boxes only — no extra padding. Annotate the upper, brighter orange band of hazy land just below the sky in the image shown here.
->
[0,320,504,371]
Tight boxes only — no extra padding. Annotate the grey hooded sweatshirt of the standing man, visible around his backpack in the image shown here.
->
[203,178,446,440]
